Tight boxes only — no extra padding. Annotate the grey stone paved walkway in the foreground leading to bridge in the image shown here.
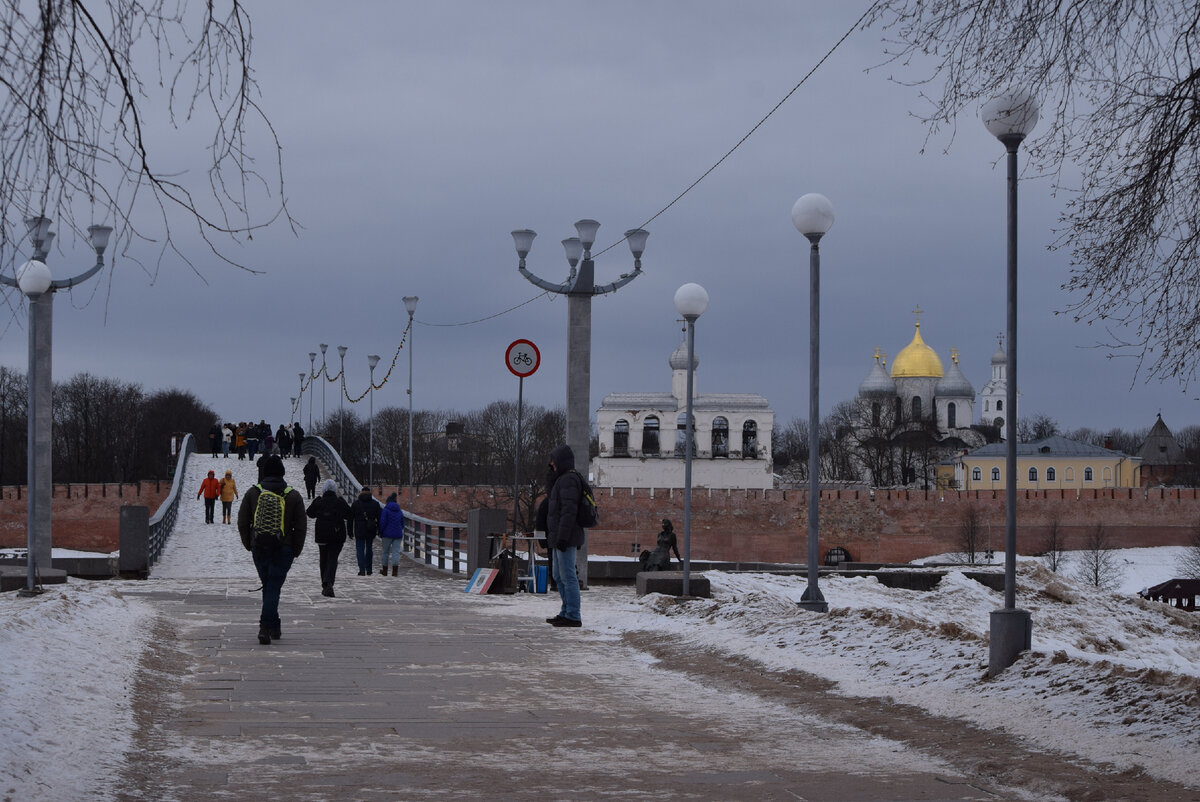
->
[114,565,1014,801]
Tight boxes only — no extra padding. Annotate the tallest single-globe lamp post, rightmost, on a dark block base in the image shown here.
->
[980,90,1038,676]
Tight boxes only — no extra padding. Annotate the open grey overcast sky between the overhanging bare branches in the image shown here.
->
[0,0,1196,441]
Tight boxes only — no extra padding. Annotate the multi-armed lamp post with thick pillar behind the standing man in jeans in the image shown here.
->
[512,220,650,588]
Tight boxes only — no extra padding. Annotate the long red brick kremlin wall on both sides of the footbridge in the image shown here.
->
[0,481,1200,563]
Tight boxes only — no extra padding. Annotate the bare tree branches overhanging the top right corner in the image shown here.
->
[868,0,1200,385]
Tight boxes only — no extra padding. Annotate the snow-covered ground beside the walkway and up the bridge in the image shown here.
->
[0,456,1200,800]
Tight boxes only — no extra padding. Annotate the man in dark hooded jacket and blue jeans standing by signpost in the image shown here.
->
[546,445,584,627]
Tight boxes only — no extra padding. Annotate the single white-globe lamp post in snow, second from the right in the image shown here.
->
[792,192,833,612]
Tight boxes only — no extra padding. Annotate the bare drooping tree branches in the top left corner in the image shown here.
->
[0,0,290,283]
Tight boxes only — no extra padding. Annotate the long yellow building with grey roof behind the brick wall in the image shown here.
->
[937,436,1141,490]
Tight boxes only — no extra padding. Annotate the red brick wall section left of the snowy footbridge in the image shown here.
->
[0,481,170,553]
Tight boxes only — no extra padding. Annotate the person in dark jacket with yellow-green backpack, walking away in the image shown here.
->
[238,456,308,645]
